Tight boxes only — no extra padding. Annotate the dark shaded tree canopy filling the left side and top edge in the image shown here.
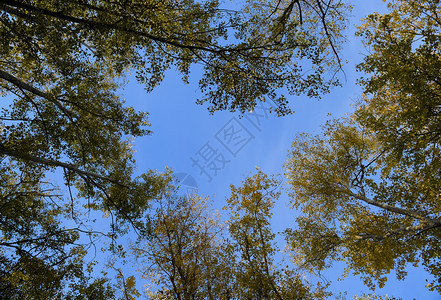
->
[0,0,347,299]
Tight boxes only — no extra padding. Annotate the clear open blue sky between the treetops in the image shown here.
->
[123,0,439,299]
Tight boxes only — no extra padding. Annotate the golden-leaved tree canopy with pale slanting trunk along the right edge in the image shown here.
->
[286,1,441,293]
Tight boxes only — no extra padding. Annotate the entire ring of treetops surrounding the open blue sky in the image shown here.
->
[4,0,441,299]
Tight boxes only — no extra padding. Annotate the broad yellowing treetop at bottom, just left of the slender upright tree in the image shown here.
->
[132,194,235,300]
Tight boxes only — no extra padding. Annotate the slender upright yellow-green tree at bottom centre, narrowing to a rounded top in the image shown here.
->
[225,171,329,300]
